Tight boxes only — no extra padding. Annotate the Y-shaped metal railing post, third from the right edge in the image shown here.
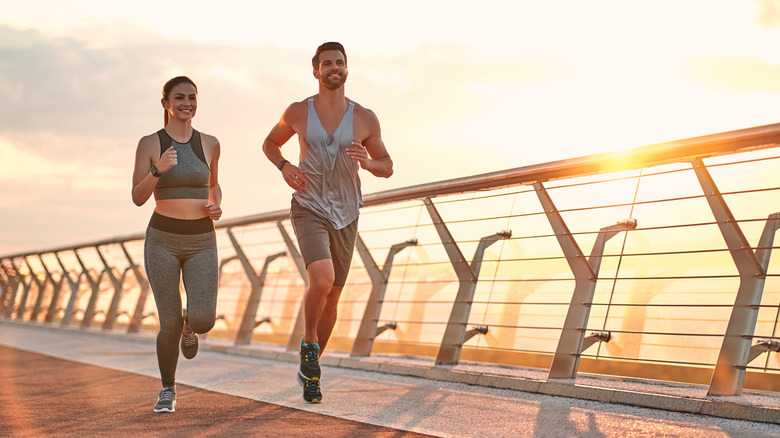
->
[423,198,512,365]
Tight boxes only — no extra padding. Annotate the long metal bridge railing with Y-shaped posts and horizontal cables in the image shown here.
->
[0,124,780,395]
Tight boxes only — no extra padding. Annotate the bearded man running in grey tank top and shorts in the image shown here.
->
[263,42,393,403]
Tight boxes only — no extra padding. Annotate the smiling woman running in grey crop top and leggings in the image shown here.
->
[133,76,222,412]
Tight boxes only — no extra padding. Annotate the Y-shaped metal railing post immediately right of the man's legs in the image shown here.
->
[350,233,417,356]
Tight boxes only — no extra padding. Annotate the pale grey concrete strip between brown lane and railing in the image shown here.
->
[0,320,780,438]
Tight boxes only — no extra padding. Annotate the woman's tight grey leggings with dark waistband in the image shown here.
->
[144,226,219,386]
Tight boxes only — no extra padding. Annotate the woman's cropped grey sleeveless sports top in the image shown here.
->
[154,129,211,200]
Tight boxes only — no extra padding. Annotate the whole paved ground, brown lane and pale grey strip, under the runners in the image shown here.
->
[0,320,780,438]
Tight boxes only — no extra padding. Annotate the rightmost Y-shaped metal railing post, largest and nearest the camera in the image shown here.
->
[692,159,778,395]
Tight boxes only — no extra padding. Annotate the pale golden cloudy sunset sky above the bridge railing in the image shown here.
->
[0,0,780,256]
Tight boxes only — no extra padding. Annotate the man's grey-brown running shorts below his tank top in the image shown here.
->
[290,199,358,287]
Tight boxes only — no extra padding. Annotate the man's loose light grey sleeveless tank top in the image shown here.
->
[293,96,363,230]
